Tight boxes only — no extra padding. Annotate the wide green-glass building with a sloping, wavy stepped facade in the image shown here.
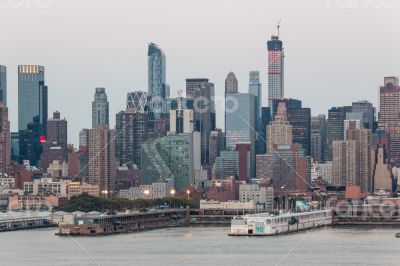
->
[142,132,201,192]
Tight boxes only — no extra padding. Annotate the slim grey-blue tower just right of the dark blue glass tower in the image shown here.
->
[311,115,326,162]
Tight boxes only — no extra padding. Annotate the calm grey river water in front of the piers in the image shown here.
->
[0,227,400,266]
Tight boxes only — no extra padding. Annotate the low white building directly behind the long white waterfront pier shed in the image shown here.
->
[239,184,274,210]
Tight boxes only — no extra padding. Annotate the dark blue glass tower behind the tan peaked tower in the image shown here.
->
[272,98,311,155]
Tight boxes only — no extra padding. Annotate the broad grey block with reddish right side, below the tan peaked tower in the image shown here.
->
[264,144,311,192]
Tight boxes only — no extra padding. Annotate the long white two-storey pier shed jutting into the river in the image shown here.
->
[229,209,332,236]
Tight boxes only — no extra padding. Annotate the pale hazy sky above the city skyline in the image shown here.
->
[0,0,400,145]
